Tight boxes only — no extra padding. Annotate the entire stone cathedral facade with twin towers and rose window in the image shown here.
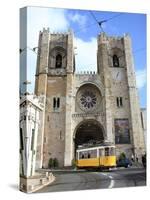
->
[35,29,145,168]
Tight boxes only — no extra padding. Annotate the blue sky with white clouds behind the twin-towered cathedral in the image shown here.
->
[21,7,146,107]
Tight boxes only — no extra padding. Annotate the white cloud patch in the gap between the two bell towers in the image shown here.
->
[74,38,97,71]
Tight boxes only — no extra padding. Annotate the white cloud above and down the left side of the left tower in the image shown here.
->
[24,7,69,92]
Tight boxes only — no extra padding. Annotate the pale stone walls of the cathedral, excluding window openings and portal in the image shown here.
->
[35,30,144,167]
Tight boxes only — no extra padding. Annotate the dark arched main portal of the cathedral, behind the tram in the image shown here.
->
[74,120,104,149]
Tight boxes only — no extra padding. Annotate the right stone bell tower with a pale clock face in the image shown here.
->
[97,33,145,158]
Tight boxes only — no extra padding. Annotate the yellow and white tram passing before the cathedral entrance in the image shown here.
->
[76,145,116,169]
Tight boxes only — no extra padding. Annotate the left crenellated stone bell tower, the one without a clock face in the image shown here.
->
[35,29,75,167]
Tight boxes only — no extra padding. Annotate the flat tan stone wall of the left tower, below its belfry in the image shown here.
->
[43,77,66,167]
